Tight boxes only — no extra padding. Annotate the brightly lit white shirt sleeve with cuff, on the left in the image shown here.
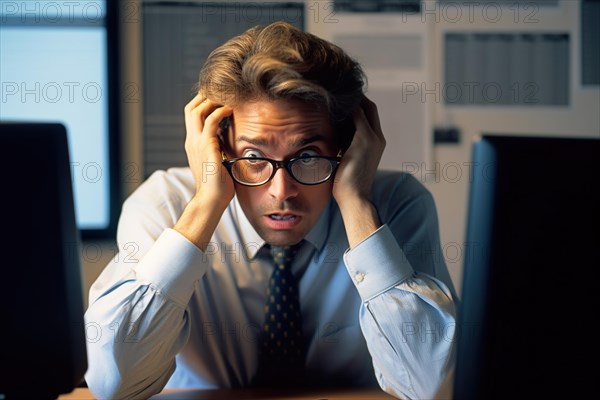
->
[85,170,208,399]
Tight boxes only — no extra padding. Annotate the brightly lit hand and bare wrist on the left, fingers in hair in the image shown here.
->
[173,93,235,251]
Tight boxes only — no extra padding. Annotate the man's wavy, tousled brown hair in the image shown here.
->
[198,22,366,147]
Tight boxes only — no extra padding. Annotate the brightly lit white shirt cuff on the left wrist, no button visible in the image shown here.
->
[134,228,208,308]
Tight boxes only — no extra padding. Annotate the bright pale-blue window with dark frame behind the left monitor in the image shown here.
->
[0,0,120,240]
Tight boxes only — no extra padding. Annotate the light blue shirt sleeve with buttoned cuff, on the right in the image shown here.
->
[344,185,456,399]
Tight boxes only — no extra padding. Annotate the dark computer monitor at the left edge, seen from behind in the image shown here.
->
[0,122,87,400]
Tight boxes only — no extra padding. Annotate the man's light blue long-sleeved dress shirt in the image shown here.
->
[85,168,457,399]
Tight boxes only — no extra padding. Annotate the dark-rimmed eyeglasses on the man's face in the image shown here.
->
[221,150,342,186]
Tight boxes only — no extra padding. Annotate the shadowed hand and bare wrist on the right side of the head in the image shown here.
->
[333,96,385,247]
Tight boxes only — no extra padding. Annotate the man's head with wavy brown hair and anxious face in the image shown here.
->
[199,22,365,245]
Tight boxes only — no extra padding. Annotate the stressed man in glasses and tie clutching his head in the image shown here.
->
[86,23,456,398]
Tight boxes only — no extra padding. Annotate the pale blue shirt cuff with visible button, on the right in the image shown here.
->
[344,225,414,301]
